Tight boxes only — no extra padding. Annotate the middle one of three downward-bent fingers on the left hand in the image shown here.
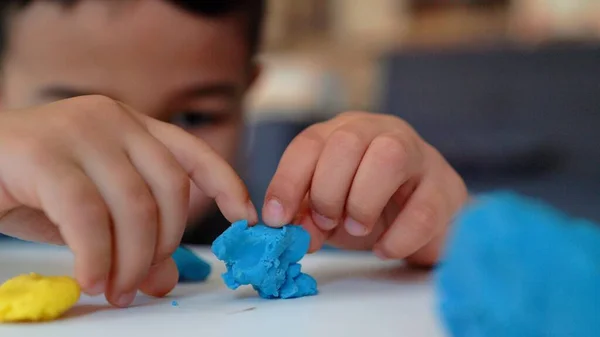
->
[79,146,158,307]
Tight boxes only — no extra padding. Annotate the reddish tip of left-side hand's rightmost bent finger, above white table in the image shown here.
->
[140,258,179,297]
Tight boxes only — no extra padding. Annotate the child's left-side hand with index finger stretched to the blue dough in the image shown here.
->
[0,96,257,306]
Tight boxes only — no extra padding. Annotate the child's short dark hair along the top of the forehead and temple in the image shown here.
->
[0,0,266,56]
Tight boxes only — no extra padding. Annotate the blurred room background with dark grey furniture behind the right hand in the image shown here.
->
[241,0,600,221]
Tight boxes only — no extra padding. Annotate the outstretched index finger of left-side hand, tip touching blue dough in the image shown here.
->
[146,119,258,224]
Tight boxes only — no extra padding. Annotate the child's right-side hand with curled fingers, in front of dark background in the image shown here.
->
[263,113,467,265]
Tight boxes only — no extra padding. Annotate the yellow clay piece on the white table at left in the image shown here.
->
[0,273,81,323]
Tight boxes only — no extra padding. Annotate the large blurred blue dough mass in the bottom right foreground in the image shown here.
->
[435,192,600,337]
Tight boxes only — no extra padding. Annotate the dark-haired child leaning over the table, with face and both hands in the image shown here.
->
[0,0,467,307]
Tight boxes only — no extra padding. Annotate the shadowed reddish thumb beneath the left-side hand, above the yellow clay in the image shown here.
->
[0,206,64,245]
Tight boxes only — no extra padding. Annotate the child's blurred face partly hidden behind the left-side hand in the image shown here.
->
[0,0,255,222]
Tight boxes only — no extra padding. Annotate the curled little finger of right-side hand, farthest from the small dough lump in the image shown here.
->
[373,178,452,259]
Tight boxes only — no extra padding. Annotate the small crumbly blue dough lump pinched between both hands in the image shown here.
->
[212,221,318,299]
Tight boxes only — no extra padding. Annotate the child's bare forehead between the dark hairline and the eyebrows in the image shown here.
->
[6,0,248,80]
